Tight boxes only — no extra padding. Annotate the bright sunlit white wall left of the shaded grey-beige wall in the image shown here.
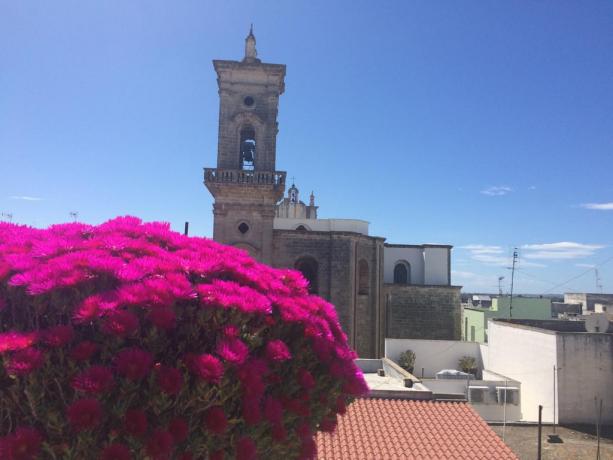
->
[483,320,557,422]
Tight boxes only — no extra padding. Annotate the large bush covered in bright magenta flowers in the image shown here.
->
[0,217,366,460]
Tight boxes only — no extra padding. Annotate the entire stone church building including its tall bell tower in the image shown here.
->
[204,31,461,358]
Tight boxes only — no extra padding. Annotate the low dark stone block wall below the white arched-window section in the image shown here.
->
[384,284,461,340]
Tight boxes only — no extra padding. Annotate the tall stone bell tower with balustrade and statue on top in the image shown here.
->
[204,28,285,264]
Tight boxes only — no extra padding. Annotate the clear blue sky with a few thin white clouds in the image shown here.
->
[0,0,613,293]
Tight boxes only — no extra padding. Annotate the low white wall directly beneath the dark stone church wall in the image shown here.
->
[385,339,482,378]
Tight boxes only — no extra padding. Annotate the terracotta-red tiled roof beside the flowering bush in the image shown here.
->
[317,398,517,460]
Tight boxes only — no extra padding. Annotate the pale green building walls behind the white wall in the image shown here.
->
[462,297,551,343]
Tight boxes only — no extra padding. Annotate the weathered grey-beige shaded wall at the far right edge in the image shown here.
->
[557,333,613,424]
